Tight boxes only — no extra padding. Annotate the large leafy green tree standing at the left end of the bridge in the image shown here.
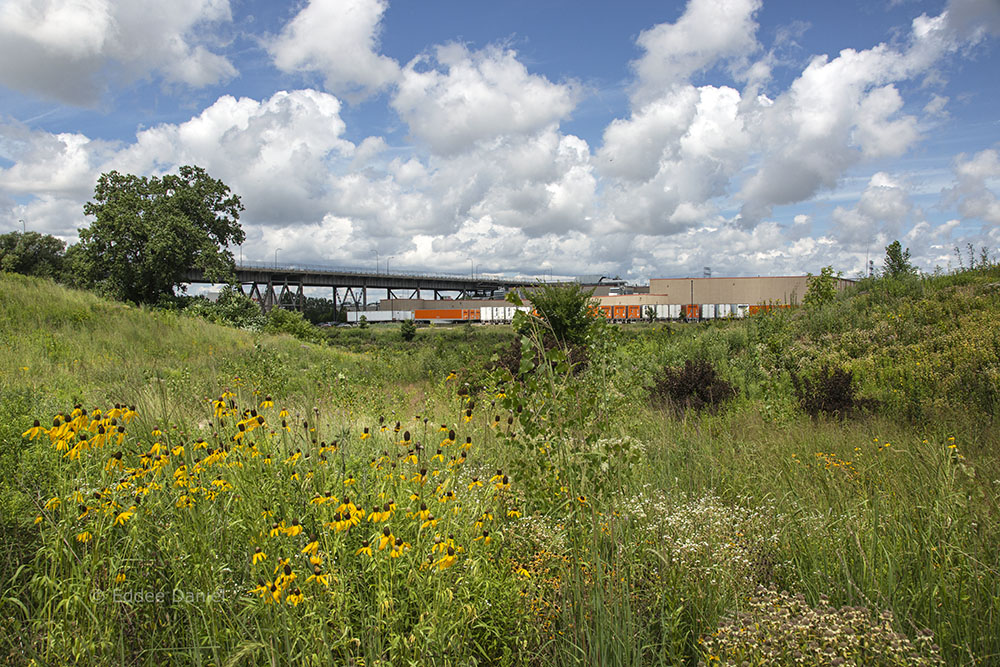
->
[77,166,245,303]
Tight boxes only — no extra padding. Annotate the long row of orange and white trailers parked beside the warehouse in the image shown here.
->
[347,303,789,324]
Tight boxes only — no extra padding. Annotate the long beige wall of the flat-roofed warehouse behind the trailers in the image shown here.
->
[649,276,853,306]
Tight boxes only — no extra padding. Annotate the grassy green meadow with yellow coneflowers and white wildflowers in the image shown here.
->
[0,270,1000,665]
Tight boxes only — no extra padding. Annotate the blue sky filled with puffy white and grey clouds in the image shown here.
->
[0,0,1000,281]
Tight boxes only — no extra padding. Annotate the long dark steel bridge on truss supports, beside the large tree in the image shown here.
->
[184,262,540,312]
